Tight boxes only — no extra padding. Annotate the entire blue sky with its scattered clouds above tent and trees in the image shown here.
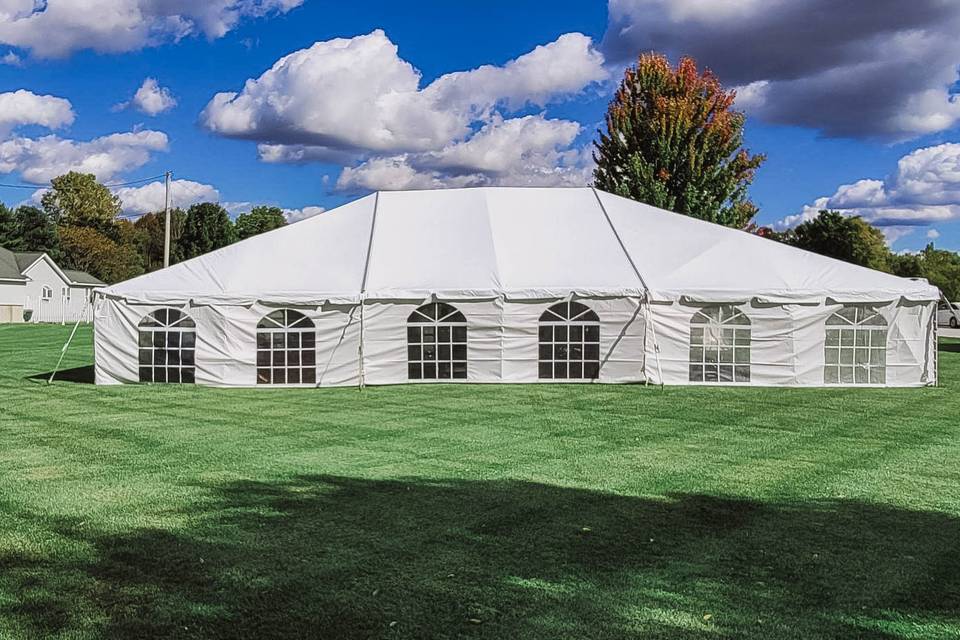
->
[0,0,960,250]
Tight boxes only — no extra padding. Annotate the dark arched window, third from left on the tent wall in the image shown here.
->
[407,302,467,380]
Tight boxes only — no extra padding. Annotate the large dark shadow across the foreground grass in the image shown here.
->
[0,476,960,639]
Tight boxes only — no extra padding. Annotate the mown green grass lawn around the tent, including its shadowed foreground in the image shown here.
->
[0,326,960,640]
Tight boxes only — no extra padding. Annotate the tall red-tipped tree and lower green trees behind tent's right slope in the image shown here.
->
[594,53,960,301]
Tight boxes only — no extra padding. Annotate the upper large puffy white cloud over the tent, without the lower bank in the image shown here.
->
[201,30,607,158]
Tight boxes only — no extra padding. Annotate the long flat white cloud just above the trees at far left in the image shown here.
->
[0,130,167,183]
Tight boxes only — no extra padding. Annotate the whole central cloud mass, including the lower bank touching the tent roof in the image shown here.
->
[201,30,609,190]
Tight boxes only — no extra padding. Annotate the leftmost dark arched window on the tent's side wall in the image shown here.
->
[139,309,197,383]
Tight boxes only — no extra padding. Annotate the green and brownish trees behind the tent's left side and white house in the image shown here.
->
[0,172,287,283]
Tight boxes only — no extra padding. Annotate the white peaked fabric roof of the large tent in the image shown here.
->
[101,187,939,304]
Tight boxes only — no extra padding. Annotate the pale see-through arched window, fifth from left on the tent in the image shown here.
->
[690,305,750,382]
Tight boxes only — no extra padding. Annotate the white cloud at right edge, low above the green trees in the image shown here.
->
[775,143,960,239]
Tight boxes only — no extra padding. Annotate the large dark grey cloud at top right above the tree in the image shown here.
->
[601,0,960,139]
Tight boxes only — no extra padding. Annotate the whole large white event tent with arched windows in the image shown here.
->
[95,188,939,386]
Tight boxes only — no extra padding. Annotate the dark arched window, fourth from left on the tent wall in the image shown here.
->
[540,302,600,380]
